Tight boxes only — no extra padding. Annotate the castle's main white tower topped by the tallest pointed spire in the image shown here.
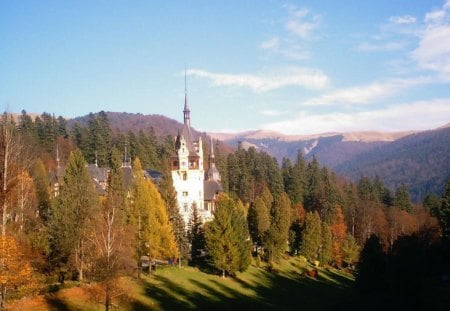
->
[171,77,212,225]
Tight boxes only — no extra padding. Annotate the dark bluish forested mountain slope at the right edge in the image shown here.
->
[334,127,450,201]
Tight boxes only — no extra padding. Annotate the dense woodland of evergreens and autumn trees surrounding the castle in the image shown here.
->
[0,111,450,309]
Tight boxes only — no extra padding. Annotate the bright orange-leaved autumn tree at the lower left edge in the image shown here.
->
[0,235,33,310]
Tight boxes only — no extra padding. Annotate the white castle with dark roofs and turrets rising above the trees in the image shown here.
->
[171,89,222,225]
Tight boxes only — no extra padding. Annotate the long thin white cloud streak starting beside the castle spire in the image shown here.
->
[186,67,329,93]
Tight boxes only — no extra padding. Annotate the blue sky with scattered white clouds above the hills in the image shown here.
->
[0,0,450,134]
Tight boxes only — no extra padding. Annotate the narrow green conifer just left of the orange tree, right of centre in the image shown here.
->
[300,212,322,261]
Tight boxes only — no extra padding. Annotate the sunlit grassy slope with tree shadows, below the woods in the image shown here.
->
[6,259,354,310]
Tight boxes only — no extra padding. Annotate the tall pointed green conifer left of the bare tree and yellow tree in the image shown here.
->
[49,150,99,281]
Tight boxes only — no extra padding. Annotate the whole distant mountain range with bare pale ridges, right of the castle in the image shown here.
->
[211,124,450,201]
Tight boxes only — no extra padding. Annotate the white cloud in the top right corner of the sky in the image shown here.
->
[411,2,450,77]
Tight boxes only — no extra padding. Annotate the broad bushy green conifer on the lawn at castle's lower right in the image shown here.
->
[205,194,250,277]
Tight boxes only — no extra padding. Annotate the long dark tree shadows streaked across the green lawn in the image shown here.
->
[134,270,354,310]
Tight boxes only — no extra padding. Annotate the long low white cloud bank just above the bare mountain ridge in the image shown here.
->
[263,98,450,135]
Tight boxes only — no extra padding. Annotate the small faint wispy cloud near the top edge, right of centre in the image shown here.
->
[284,5,320,39]
